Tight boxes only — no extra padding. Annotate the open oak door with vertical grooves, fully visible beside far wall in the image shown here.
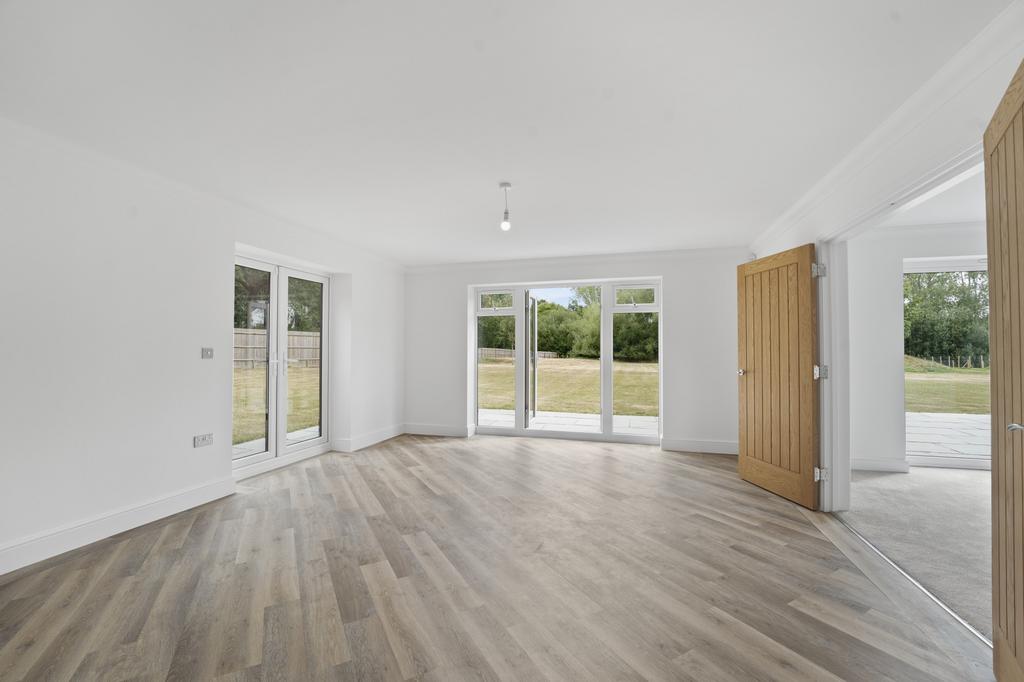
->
[736,244,818,509]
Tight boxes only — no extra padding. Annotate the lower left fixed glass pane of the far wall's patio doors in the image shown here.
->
[476,315,515,428]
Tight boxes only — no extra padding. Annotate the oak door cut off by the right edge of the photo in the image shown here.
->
[985,59,1024,681]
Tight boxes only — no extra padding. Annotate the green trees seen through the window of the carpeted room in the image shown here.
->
[903,272,988,357]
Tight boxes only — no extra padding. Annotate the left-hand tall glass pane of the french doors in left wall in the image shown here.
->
[231,265,270,458]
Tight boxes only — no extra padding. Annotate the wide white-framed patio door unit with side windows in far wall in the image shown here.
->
[474,282,660,442]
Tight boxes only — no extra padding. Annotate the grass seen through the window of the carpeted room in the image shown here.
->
[903,356,990,415]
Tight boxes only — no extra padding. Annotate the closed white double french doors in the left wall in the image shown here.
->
[231,258,329,467]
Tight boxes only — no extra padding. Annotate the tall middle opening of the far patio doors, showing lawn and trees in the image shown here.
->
[526,287,601,432]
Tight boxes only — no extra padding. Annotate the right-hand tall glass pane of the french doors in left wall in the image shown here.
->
[287,278,324,443]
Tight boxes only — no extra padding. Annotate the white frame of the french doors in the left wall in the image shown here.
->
[231,255,331,475]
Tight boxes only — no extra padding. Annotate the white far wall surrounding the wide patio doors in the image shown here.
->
[406,249,749,454]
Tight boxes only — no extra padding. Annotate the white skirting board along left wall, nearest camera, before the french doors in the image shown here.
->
[0,476,234,576]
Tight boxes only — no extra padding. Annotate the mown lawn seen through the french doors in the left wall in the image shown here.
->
[231,367,321,444]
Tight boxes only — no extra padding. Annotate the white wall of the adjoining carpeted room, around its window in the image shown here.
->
[848,224,986,471]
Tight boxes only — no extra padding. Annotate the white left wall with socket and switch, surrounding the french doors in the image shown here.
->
[0,120,403,573]
